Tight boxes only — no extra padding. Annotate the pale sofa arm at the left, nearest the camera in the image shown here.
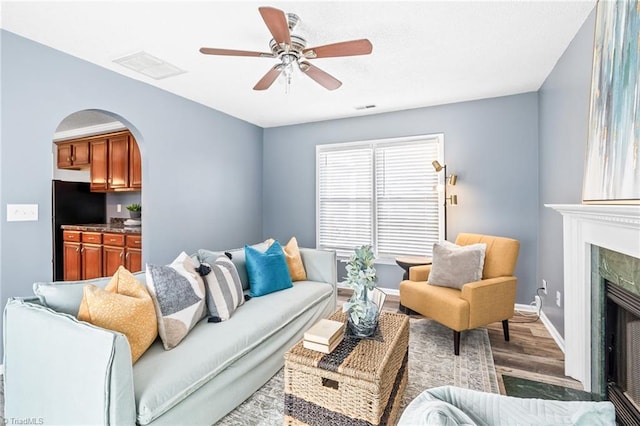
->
[4,298,136,425]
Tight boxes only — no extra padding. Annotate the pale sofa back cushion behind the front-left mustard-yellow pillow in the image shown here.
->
[33,272,146,317]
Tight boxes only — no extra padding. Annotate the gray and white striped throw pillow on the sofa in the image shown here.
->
[205,255,244,322]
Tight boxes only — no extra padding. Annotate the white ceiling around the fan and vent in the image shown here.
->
[0,0,595,127]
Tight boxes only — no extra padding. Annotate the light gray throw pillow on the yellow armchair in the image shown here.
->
[428,241,487,289]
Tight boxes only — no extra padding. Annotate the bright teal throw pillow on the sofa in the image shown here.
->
[244,241,293,297]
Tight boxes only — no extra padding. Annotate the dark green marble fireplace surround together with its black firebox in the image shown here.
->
[591,245,640,425]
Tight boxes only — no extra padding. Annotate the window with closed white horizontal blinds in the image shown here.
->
[316,135,444,258]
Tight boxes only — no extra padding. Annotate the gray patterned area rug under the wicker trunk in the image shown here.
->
[216,318,500,426]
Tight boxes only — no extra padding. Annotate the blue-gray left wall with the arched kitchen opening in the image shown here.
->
[0,31,262,352]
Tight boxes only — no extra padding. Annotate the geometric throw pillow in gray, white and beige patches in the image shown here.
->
[146,252,207,350]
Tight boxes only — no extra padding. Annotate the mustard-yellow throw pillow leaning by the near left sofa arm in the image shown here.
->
[78,266,158,364]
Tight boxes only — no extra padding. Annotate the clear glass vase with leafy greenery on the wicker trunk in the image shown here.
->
[342,245,378,337]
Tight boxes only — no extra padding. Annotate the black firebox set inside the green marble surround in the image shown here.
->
[601,276,640,425]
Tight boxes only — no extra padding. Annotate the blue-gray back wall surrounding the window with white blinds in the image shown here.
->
[263,93,539,303]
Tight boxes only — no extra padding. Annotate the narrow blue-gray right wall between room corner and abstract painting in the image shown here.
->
[538,11,595,336]
